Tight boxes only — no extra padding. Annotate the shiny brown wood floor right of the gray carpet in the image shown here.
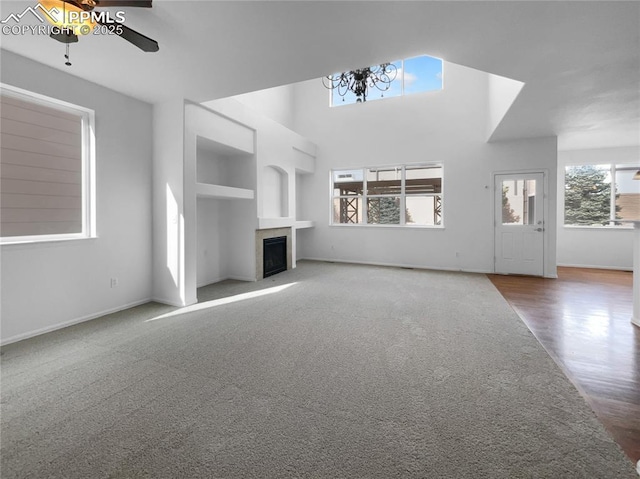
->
[488,268,640,463]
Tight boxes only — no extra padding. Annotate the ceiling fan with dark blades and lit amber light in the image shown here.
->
[40,0,160,52]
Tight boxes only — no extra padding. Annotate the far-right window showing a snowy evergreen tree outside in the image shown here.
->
[564,164,640,227]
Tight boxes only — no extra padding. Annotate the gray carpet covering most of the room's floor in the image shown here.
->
[1,262,637,479]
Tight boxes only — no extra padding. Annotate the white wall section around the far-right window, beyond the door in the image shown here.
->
[557,146,640,270]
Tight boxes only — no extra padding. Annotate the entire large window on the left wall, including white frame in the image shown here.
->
[0,84,95,244]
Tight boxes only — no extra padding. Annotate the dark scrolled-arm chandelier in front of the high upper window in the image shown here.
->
[322,63,398,103]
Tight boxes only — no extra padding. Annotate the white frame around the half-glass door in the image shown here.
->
[491,168,557,278]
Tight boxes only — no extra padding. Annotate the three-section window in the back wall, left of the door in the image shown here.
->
[331,164,442,227]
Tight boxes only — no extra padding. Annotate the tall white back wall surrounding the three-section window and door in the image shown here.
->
[294,62,557,276]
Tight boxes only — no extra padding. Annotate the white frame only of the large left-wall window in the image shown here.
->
[0,82,97,246]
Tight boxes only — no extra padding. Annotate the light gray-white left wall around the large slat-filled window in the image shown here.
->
[0,50,152,343]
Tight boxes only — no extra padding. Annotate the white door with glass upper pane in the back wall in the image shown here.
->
[494,173,545,276]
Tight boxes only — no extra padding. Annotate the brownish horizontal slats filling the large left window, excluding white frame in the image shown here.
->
[0,94,83,237]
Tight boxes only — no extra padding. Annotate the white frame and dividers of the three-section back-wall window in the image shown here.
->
[329,162,445,229]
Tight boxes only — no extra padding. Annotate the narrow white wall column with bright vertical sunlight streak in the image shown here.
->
[153,98,190,306]
